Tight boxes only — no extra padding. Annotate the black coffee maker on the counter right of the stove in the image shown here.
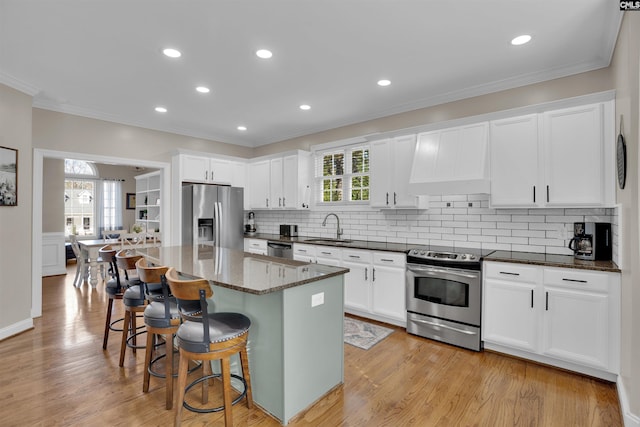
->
[569,222,612,261]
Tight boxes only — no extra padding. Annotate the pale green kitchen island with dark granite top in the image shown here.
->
[138,246,349,425]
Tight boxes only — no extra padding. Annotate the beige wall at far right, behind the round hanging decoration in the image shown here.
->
[610,12,640,416]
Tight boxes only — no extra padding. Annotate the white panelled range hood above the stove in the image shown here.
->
[409,122,491,195]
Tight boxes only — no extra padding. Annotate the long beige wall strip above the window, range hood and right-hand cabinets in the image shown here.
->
[253,68,612,157]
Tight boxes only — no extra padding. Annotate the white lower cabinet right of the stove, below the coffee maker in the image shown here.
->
[482,262,620,381]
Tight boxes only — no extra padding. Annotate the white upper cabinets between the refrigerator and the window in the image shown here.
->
[248,151,311,209]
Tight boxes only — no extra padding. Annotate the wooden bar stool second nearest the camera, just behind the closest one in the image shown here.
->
[136,258,180,409]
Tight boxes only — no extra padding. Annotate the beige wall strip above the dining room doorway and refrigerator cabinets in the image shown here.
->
[33,108,253,162]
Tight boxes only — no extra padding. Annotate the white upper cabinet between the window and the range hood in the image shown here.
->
[369,135,428,209]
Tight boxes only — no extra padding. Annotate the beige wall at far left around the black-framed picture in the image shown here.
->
[0,85,33,330]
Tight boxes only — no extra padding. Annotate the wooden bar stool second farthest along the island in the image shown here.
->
[116,250,146,367]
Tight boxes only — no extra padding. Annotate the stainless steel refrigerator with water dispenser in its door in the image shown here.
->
[182,184,244,250]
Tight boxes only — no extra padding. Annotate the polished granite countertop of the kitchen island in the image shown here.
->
[137,246,349,295]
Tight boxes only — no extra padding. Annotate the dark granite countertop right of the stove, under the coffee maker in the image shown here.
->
[483,251,620,273]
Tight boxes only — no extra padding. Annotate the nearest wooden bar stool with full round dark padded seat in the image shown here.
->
[165,268,253,427]
